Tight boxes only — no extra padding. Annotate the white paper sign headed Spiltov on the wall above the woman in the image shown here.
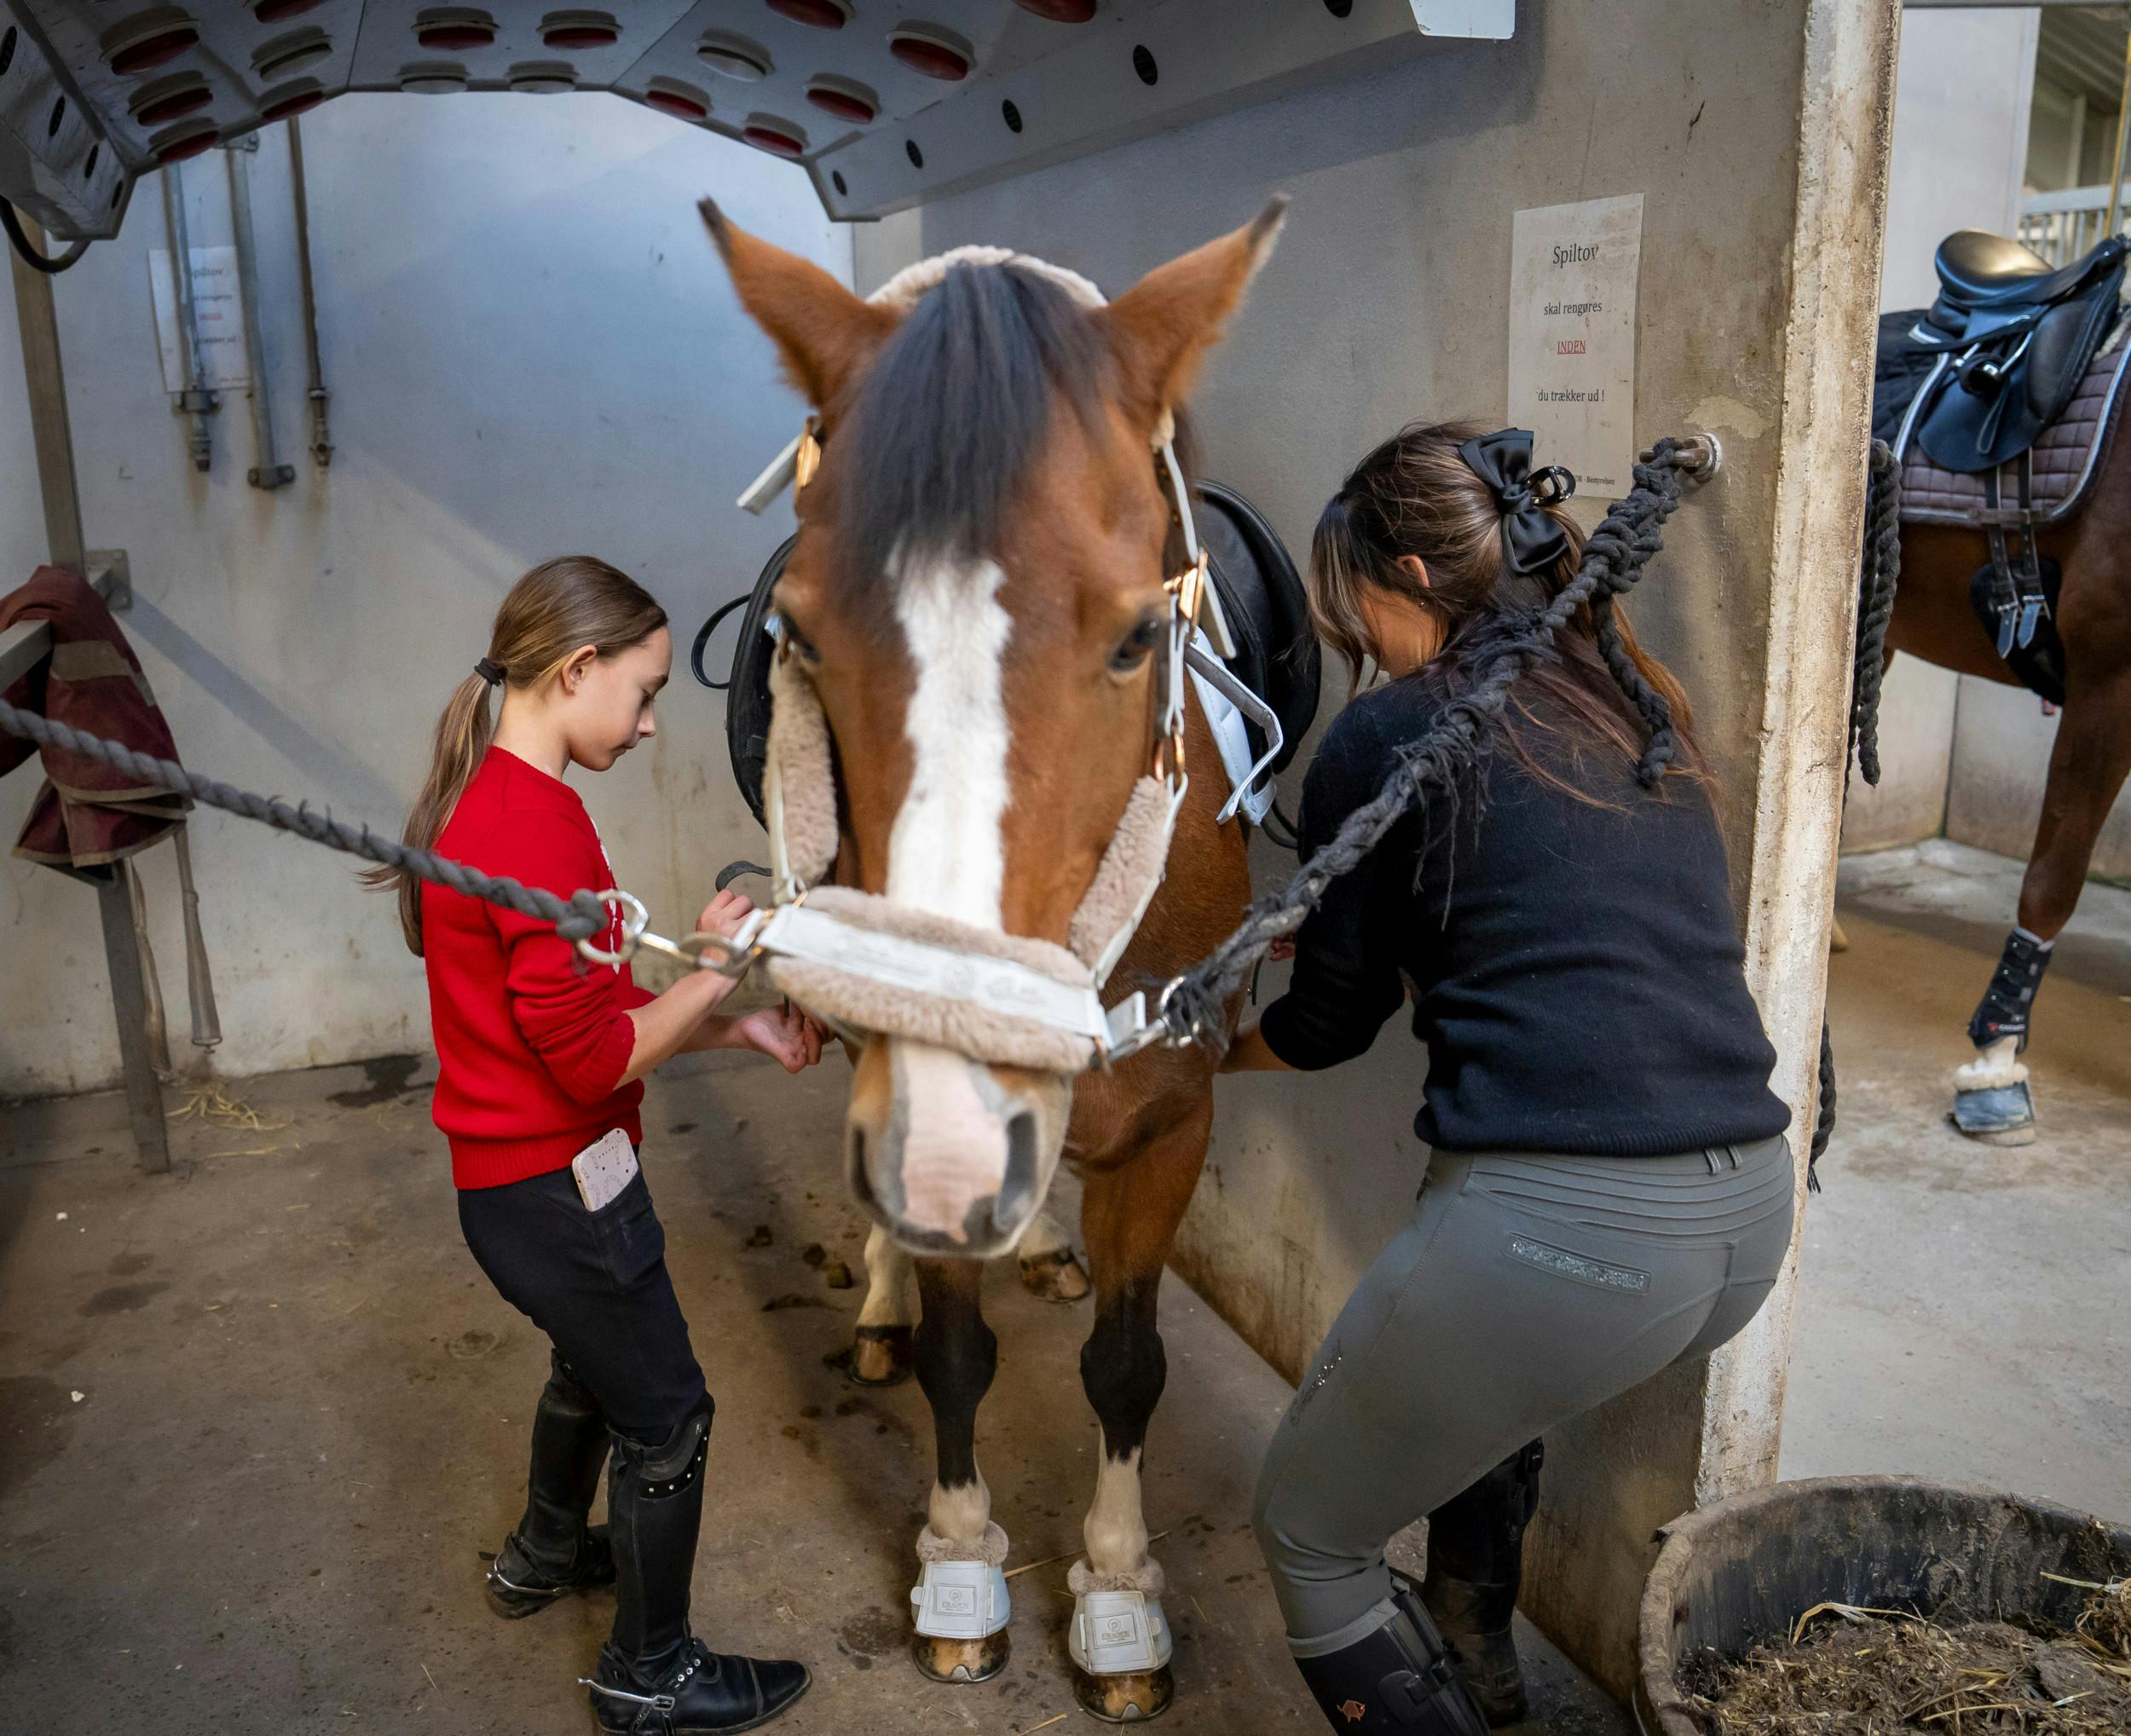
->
[1509,193,1643,500]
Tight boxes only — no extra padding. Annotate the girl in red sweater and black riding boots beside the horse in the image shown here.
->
[382,556,821,1736]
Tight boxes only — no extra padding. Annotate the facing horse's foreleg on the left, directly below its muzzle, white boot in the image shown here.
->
[910,1259,1010,1683]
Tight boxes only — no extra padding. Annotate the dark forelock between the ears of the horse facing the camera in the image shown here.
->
[835,264,1111,585]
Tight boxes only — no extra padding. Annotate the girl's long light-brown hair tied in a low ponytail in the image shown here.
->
[362,554,667,959]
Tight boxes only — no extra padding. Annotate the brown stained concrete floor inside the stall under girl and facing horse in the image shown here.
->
[0,1057,1624,1736]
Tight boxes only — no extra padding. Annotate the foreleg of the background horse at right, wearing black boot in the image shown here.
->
[1955,671,2131,1146]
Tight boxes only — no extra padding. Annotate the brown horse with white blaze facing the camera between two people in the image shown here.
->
[706,205,1281,1719]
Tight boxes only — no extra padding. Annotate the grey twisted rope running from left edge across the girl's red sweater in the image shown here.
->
[0,699,612,942]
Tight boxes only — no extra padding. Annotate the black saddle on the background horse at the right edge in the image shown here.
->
[1909,230,2131,473]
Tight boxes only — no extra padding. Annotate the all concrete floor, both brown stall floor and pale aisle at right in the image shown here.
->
[0,834,2131,1736]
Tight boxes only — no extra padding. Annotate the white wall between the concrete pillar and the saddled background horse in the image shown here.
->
[1844,6,2041,850]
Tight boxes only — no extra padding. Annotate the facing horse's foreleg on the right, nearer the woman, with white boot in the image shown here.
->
[1068,1097,1213,1723]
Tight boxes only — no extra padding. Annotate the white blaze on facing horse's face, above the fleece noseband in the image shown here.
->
[889,560,1013,929]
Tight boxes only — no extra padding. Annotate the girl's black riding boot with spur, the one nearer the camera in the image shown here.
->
[584,1399,810,1736]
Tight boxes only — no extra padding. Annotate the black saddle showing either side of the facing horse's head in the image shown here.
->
[689,482,1321,820]
